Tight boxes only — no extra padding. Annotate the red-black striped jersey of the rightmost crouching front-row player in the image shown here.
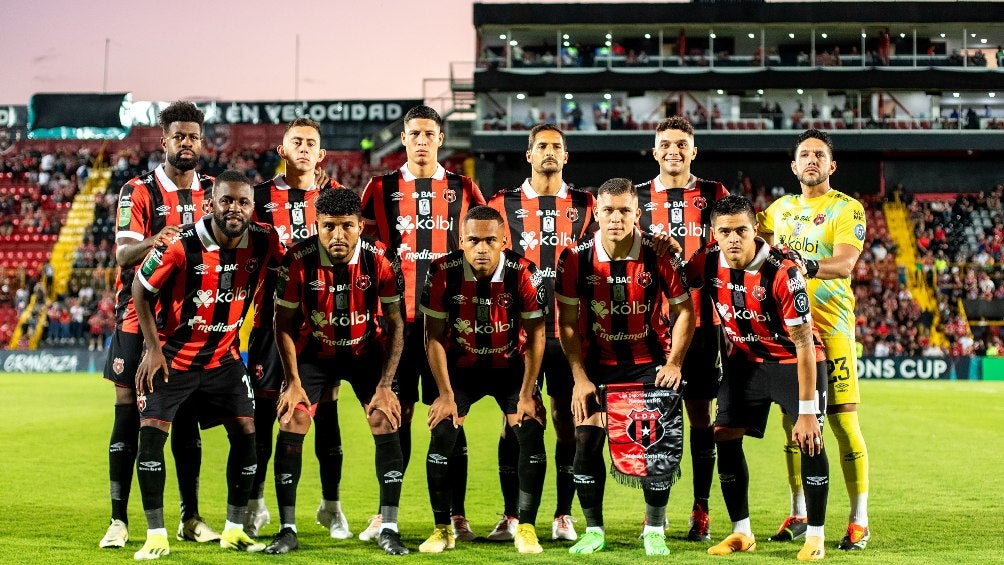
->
[684,238,824,363]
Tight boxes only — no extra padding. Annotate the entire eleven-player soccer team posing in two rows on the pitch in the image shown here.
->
[54,97,870,561]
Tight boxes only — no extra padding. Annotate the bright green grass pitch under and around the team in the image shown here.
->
[0,374,1004,564]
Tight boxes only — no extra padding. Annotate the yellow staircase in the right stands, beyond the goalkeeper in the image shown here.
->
[884,198,949,347]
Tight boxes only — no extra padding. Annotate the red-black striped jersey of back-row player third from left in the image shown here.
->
[362,165,485,322]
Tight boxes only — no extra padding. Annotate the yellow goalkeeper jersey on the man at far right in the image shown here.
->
[757,190,865,338]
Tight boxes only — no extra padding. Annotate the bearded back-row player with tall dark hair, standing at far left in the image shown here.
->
[98,102,220,548]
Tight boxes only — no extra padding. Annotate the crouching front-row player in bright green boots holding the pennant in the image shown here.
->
[555,179,694,555]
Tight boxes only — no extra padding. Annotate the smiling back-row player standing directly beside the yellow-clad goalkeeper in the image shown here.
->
[638,116,729,541]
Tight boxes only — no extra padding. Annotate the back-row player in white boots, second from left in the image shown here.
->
[244,117,352,539]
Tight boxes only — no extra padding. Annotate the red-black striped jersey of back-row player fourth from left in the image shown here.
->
[488,181,595,337]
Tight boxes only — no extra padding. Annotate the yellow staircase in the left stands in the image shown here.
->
[8,166,111,349]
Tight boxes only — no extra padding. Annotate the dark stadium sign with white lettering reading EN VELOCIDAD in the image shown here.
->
[133,99,422,125]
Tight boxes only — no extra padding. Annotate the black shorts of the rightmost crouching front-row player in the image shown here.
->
[715,355,826,438]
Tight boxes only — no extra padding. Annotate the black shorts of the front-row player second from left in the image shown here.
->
[296,347,387,406]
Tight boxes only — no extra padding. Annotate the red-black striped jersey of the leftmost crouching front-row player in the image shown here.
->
[137,217,283,371]
